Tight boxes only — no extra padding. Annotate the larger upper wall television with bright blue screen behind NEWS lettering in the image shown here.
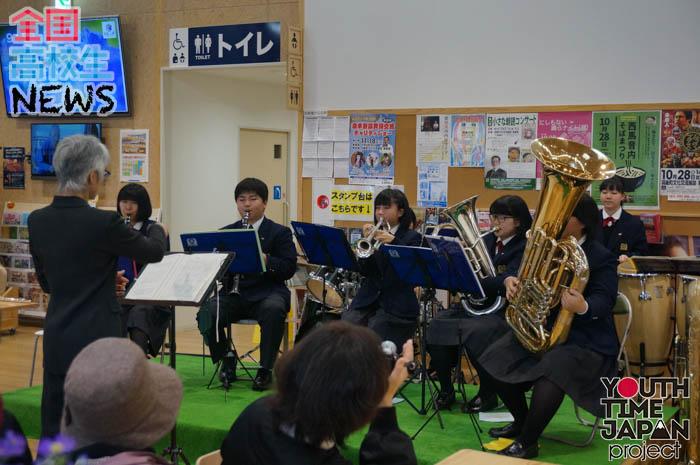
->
[0,16,130,117]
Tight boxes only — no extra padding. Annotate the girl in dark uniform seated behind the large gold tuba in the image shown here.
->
[479,194,619,458]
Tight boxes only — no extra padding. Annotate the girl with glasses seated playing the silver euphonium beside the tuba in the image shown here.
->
[427,195,532,412]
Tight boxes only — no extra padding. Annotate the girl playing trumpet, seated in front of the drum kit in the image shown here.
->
[342,189,421,347]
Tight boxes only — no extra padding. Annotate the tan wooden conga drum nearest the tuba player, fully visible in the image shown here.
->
[618,273,674,376]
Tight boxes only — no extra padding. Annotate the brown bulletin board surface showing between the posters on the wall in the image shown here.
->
[298,102,700,253]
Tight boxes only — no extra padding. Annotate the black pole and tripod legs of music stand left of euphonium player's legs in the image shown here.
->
[397,288,445,439]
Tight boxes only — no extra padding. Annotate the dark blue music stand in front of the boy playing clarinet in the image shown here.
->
[180,229,267,388]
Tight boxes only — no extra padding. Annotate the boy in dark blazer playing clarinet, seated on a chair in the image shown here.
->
[197,178,297,391]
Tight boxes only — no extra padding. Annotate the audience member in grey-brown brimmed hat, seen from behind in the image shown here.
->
[61,338,182,465]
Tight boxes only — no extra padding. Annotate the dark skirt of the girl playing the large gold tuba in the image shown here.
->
[479,331,617,417]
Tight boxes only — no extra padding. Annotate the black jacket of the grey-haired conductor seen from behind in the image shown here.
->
[27,196,165,374]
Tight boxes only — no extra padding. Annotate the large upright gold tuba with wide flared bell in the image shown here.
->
[506,138,615,353]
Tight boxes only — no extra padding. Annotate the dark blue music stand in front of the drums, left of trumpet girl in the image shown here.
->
[292,221,359,332]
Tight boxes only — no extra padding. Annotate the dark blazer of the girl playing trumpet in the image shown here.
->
[351,227,422,318]
